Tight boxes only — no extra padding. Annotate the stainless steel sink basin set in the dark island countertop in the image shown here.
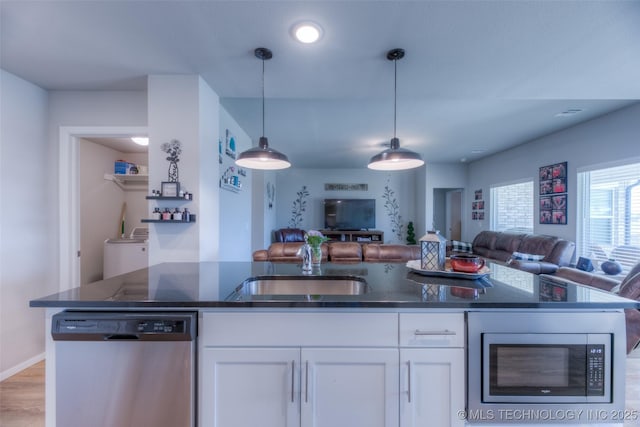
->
[236,276,367,295]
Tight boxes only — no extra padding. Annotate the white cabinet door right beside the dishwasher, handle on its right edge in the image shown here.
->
[200,348,300,427]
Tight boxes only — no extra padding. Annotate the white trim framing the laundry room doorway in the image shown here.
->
[58,126,148,291]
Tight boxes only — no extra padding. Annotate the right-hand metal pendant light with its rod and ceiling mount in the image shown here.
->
[367,49,424,171]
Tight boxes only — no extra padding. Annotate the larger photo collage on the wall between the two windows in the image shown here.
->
[539,162,567,225]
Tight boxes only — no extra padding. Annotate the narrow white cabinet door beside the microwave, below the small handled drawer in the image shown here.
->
[400,348,465,427]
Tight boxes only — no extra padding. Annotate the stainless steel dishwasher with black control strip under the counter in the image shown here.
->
[51,311,197,427]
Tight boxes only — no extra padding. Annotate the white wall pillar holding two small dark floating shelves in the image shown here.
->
[148,75,221,265]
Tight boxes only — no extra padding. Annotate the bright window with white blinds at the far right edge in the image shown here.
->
[577,163,640,272]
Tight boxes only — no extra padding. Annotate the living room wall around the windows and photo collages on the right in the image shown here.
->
[463,103,640,246]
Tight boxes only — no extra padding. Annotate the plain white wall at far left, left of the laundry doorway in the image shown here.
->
[0,70,51,380]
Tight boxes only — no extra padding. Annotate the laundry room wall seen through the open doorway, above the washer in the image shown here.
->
[80,139,148,285]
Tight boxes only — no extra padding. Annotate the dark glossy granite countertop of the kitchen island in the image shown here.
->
[30,262,640,309]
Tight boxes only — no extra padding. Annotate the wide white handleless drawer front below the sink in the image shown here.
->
[200,312,398,347]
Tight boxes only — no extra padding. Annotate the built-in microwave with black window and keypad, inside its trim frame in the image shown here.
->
[482,333,613,403]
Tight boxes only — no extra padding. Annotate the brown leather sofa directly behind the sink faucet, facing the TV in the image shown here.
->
[253,242,420,263]
